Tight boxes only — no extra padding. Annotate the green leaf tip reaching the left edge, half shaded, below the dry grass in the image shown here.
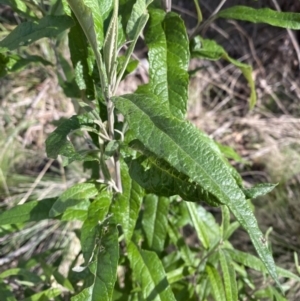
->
[0,198,57,226]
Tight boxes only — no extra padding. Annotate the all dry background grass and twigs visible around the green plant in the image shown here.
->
[0,1,300,300]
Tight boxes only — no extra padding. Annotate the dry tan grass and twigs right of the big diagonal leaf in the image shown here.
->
[178,2,300,300]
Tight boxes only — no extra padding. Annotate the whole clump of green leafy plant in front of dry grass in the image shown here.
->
[0,0,300,301]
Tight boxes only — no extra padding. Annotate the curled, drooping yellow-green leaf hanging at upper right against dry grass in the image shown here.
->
[191,36,256,109]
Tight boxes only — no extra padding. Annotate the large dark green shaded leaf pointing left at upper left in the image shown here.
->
[0,16,74,52]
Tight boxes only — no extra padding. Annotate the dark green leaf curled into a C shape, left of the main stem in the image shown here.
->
[46,113,96,163]
